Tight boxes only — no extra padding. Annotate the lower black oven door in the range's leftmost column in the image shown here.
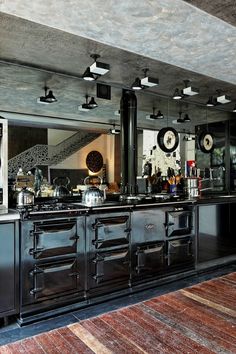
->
[22,258,83,305]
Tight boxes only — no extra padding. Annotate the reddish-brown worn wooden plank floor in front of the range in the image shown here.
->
[0,267,236,354]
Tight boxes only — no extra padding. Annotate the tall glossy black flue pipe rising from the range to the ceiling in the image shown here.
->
[120,90,138,195]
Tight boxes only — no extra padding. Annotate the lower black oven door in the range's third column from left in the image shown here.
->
[134,242,164,276]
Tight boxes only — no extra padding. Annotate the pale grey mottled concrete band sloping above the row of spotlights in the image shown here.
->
[0,0,236,84]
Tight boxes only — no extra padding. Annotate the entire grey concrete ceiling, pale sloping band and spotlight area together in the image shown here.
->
[0,0,236,131]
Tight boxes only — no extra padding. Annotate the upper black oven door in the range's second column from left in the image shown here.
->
[89,214,130,249]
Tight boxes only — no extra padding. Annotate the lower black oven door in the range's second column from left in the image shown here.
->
[90,248,130,289]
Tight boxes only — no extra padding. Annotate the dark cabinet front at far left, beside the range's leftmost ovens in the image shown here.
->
[0,221,19,317]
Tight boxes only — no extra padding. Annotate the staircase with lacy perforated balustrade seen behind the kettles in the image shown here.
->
[8,130,101,178]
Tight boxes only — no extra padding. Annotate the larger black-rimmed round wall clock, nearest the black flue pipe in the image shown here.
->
[157,128,179,152]
